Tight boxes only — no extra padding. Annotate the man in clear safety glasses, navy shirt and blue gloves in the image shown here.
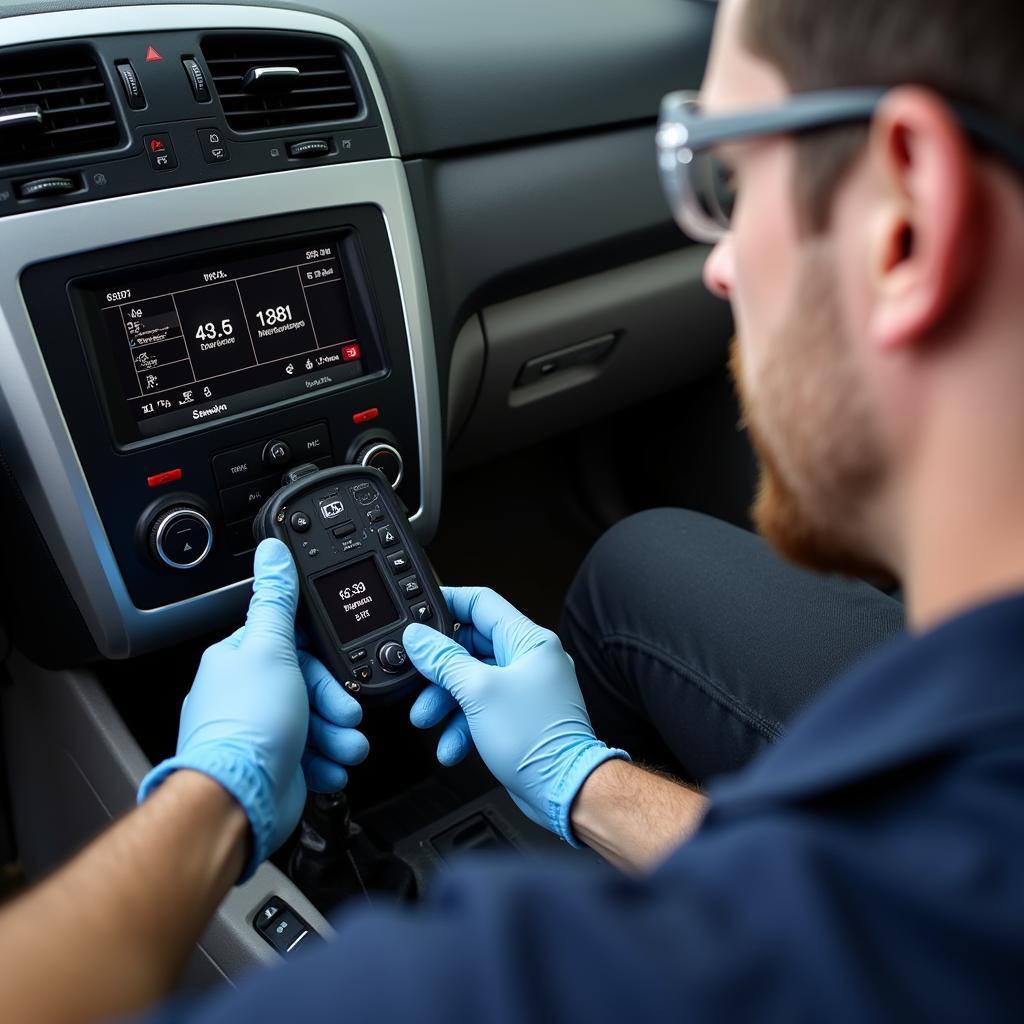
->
[0,0,1024,1024]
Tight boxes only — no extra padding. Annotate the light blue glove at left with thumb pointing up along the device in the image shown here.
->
[138,540,370,881]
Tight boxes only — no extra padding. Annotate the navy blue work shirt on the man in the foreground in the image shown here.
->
[142,597,1024,1024]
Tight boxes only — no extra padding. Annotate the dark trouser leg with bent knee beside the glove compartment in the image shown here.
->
[559,509,903,785]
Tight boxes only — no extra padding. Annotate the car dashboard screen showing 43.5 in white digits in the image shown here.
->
[81,241,367,437]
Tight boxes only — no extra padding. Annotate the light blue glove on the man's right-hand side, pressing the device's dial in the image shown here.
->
[402,587,629,846]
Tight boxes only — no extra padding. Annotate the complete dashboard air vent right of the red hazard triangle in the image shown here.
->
[203,34,359,132]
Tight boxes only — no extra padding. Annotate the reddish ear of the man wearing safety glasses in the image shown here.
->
[868,86,979,349]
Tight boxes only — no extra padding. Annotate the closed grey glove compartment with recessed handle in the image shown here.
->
[449,247,731,469]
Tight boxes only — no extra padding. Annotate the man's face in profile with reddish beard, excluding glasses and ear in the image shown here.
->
[701,0,884,572]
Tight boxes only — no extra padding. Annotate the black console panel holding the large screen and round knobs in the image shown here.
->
[23,206,421,609]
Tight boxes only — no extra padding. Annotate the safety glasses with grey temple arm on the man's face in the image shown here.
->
[657,89,1024,244]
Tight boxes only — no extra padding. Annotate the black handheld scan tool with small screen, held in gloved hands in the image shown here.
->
[253,466,454,702]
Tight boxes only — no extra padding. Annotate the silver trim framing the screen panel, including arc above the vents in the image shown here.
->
[0,5,443,658]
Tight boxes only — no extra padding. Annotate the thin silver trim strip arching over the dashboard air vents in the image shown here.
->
[0,4,399,157]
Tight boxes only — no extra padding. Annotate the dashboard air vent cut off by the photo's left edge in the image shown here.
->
[0,46,121,164]
